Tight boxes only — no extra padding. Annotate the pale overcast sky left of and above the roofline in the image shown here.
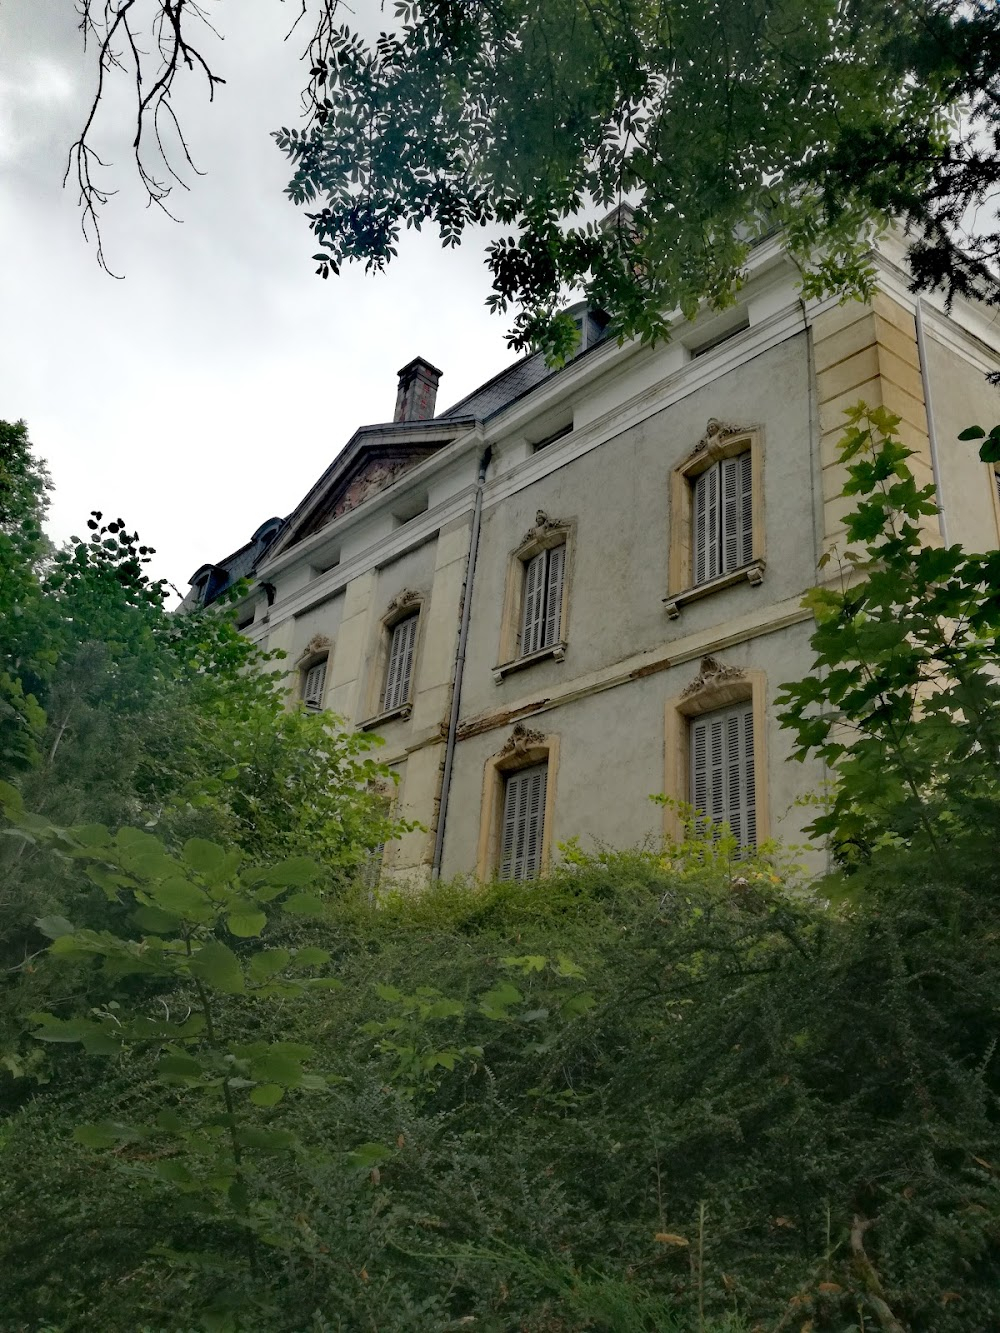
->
[0,0,512,591]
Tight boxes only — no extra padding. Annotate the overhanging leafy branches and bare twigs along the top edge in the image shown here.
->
[60,0,1000,355]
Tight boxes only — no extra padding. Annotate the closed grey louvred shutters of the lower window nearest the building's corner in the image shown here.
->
[689,704,757,846]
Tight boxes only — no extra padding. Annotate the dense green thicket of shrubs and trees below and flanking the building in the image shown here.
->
[0,409,1000,1333]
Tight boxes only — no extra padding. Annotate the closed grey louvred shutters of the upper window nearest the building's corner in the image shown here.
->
[692,449,753,584]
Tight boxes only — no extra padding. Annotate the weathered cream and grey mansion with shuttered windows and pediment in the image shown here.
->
[192,240,1000,882]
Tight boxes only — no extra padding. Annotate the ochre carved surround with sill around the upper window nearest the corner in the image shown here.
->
[663,417,767,620]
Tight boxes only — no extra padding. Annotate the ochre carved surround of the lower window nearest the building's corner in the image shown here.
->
[663,657,771,844]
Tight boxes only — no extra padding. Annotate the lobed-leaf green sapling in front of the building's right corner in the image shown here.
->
[779,404,1000,862]
